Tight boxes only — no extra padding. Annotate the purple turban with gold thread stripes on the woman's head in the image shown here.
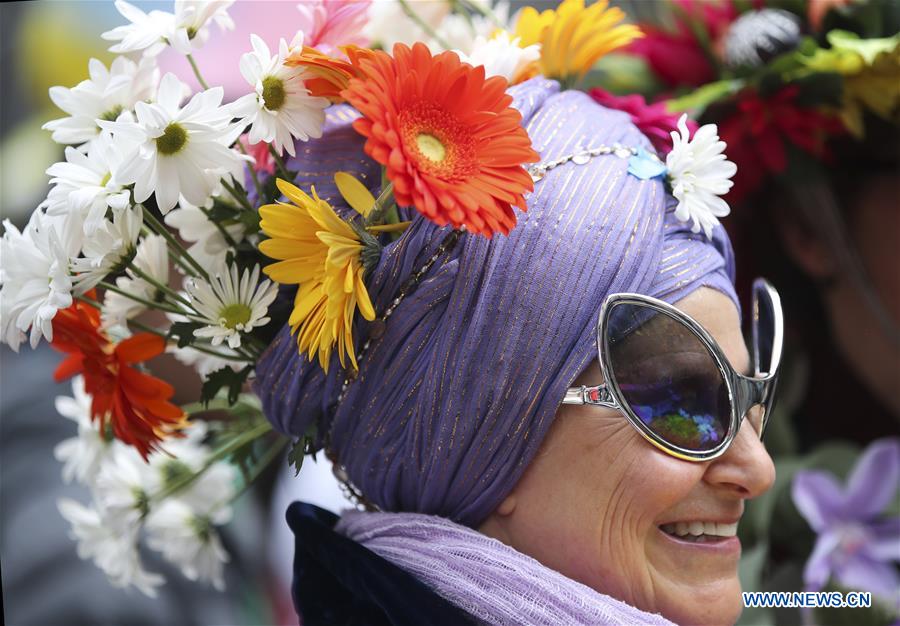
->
[255,78,737,526]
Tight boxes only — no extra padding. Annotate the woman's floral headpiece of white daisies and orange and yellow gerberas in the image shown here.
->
[0,0,735,595]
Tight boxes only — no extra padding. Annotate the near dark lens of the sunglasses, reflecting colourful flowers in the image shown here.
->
[605,303,731,452]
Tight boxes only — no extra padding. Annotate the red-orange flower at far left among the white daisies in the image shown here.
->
[52,294,186,459]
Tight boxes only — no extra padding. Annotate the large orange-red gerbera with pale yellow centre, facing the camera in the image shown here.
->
[341,43,539,237]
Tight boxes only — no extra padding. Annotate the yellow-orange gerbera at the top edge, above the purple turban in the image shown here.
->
[515,0,643,83]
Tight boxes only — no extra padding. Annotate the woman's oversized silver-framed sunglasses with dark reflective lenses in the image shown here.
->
[563,278,784,461]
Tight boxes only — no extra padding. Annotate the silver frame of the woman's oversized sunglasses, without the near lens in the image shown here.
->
[562,278,784,461]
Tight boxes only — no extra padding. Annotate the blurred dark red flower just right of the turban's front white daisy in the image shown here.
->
[719,85,844,201]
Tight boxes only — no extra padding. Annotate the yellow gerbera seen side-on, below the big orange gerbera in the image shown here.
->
[259,179,375,372]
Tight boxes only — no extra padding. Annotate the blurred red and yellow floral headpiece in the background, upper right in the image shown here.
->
[597,0,900,202]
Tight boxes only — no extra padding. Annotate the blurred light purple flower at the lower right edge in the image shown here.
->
[793,438,900,606]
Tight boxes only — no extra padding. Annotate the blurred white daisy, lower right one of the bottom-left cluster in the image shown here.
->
[146,499,231,591]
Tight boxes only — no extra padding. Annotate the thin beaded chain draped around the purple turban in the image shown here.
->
[325,143,661,511]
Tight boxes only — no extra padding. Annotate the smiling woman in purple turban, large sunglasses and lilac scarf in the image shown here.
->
[256,78,781,624]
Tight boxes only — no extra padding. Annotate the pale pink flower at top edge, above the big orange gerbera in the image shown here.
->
[297,0,371,55]
